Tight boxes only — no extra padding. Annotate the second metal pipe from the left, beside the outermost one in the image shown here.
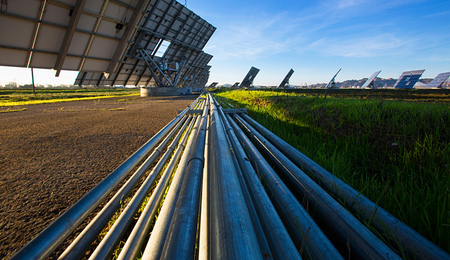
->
[58,117,186,260]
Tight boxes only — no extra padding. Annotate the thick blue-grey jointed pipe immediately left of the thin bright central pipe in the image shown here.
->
[161,96,209,259]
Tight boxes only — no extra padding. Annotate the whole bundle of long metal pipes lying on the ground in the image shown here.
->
[13,94,450,259]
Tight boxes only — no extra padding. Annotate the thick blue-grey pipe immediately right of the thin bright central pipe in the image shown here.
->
[208,95,263,259]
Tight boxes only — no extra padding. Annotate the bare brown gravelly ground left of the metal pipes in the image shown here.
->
[0,96,197,258]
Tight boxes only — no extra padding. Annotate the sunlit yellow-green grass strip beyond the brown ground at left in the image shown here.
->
[0,88,139,107]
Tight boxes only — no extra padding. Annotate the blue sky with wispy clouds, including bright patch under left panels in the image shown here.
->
[0,0,450,85]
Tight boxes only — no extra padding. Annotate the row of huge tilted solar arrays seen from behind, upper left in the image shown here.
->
[0,0,215,86]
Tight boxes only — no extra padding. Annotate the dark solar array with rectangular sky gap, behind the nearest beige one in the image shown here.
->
[80,0,215,86]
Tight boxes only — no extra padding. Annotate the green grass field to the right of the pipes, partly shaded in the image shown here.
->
[216,90,450,252]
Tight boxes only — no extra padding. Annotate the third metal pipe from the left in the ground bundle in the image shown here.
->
[89,116,190,259]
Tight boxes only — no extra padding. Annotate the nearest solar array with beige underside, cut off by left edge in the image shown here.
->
[0,0,139,71]
